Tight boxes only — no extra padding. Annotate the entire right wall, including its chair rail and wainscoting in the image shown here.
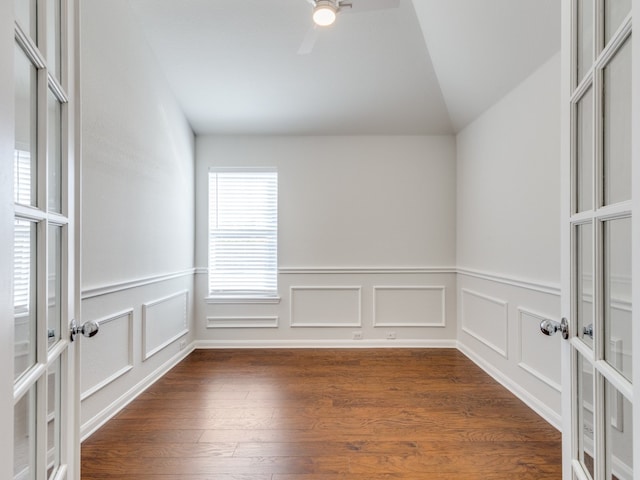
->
[457,55,560,426]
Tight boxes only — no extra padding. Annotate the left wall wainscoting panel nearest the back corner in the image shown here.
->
[142,290,189,360]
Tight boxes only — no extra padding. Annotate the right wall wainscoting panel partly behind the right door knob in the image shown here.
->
[518,307,561,392]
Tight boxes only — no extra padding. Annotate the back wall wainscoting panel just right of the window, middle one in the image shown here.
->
[290,286,362,327]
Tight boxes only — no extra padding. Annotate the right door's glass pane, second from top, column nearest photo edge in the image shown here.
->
[602,37,631,205]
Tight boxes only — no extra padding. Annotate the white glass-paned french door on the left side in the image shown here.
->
[10,0,79,480]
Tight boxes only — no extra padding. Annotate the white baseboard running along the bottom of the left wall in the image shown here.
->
[80,343,195,442]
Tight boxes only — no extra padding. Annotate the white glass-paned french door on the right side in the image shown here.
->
[562,0,640,480]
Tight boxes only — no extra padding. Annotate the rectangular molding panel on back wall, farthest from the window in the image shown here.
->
[373,286,446,327]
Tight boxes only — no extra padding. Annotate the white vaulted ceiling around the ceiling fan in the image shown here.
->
[129,0,560,135]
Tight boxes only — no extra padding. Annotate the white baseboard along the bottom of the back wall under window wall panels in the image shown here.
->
[195,339,457,349]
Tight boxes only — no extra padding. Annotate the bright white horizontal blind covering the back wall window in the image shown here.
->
[209,170,278,297]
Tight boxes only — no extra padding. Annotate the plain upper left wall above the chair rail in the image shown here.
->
[81,0,194,288]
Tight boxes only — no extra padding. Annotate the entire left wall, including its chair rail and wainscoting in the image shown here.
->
[81,0,194,435]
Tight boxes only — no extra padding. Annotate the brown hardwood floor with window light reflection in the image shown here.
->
[82,349,561,480]
